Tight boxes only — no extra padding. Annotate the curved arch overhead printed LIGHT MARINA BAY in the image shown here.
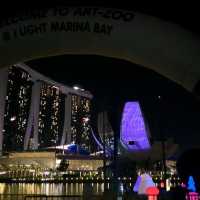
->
[0,7,200,91]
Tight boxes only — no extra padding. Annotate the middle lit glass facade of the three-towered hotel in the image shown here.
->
[38,82,64,148]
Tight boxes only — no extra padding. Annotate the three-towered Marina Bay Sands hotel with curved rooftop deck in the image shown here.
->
[0,64,95,152]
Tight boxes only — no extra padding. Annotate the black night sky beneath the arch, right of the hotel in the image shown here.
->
[27,55,200,148]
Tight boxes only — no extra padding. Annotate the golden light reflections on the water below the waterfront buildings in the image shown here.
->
[0,183,105,195]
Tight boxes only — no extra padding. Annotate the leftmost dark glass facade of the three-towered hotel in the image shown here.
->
[3,67,32,151]
